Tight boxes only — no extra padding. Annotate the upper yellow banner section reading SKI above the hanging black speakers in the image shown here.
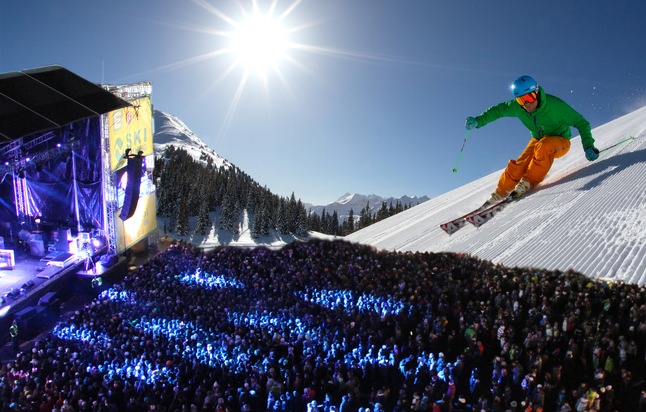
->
[108,96,154,171]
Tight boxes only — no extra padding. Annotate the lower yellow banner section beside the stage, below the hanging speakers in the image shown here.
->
[114,192,157,253]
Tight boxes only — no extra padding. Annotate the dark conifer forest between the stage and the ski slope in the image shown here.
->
[154,146,420,238]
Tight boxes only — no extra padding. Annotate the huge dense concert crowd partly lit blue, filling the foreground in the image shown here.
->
[0,240,646,412]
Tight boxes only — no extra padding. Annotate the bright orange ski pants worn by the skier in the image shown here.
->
[496,136,570,197]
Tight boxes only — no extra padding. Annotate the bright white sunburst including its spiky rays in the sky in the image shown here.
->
[182,0,400,140]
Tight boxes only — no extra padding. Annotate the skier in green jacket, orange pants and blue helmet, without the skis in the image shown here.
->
[465,76,599,208]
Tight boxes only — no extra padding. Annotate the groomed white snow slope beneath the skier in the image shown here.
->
[345,107,646,285]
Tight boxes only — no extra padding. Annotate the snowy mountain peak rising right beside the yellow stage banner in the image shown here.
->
[154,110,233,168]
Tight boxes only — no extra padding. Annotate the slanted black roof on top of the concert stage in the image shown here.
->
[0,65,130,144]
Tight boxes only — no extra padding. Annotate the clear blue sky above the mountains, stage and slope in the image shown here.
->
[0,0,646,204]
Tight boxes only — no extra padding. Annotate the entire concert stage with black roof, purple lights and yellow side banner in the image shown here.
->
[0,66,157,364]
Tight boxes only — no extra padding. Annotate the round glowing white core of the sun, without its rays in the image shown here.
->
[231,14,289,76]
